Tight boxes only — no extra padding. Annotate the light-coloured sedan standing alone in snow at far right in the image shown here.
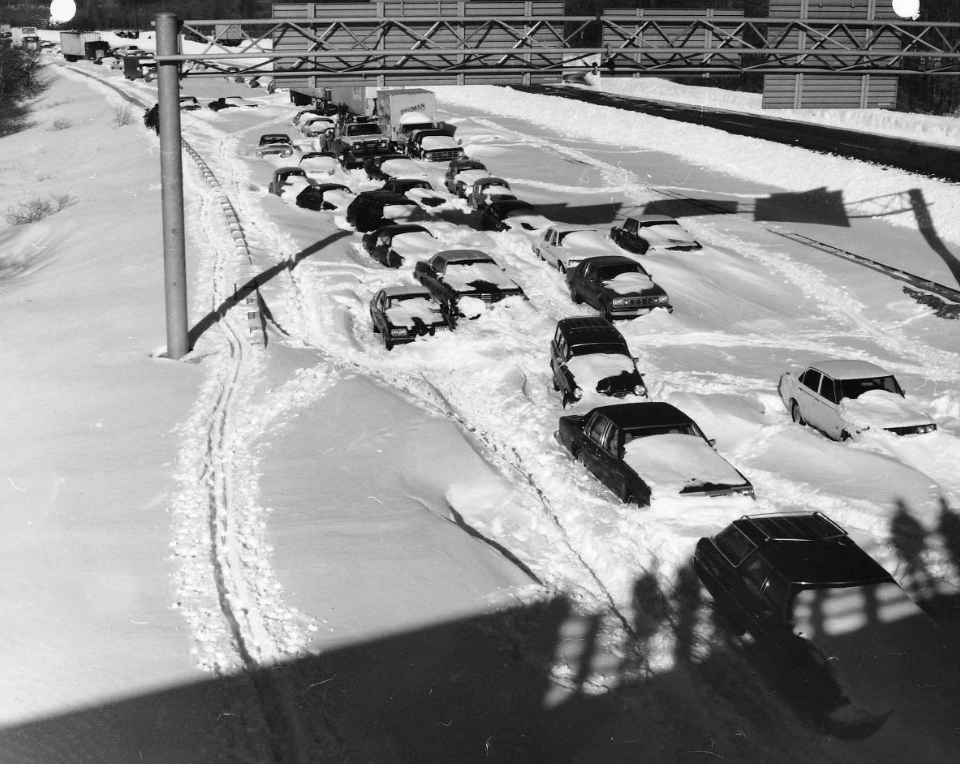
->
[777,360,937,440]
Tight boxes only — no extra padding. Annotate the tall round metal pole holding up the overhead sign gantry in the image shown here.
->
[155,13,190,360]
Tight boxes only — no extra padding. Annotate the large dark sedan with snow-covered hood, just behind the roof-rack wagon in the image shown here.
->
[556,401,754,507]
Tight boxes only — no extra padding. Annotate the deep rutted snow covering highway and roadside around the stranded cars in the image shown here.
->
[0,49,960,764]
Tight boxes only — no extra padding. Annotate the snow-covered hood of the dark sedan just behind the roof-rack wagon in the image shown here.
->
[623,434,745,498]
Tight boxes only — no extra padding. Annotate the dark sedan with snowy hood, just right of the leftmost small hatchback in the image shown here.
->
[413,249,524,325]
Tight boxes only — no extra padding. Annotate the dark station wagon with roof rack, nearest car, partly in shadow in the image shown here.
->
[693,512,955,738]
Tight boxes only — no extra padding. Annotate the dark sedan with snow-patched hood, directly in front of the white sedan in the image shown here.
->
[567,255,673,321]
